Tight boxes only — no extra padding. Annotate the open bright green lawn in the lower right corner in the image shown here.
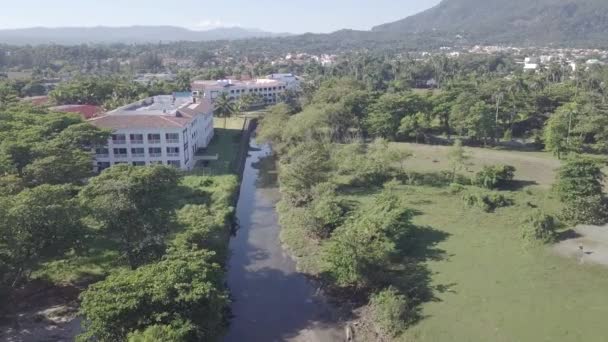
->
[394,188,608,341]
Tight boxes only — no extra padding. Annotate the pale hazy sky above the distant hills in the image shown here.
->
[0,0,440,33]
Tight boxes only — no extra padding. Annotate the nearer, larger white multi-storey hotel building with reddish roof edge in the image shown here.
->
[88,94,213,171]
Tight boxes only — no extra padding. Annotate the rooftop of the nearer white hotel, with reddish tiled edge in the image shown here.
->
[89,93,213,129]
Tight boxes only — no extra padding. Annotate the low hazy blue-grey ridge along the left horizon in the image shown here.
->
[0,26,289,45]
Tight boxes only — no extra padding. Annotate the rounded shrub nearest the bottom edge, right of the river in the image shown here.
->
[369,287,409,340]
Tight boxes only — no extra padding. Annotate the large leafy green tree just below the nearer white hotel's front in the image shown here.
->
[80,165,179,268]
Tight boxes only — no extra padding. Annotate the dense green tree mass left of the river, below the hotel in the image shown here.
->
[0,101,237,341]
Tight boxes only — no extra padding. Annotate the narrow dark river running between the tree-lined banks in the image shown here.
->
[224,140,344,342]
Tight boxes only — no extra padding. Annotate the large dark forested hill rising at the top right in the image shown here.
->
[372,0,608,46]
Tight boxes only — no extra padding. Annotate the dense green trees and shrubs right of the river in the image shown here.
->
[259,61,608,337]
